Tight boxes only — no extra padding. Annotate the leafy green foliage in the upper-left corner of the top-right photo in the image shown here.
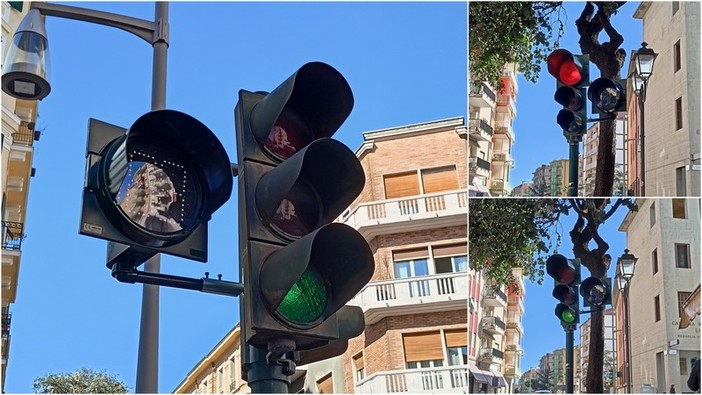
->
[468,1,564,87]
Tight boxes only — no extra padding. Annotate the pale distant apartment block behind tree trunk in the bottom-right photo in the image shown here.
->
[574,309,617,393]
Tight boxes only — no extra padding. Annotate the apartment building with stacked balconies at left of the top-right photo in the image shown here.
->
[468,64,519,196]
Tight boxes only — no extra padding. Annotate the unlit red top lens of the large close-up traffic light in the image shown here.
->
[263,107,312,161]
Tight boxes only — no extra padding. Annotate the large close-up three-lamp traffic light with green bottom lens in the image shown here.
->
[235,62,375,356]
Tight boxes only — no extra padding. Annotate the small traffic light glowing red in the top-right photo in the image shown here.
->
[546,49,590,137]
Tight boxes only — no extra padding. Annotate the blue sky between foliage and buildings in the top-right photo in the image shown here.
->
[510,2,644,186]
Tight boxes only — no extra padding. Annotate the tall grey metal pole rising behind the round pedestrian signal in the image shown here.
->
[135,1,168,394]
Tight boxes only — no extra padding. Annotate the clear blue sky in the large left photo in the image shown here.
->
[5,2,467,393]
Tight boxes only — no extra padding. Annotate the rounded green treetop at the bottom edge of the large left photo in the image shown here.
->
[34,368,129,394]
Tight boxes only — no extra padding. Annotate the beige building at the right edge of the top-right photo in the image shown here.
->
[627,1,701,196]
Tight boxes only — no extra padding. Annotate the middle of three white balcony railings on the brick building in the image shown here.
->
[351,272,468,318]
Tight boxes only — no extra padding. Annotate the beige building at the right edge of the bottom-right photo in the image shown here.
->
[617,198,700,393]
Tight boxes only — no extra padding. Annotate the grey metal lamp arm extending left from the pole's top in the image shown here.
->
[31,1,168,45]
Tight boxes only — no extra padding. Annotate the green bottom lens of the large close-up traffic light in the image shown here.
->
[277,268,328,325]
